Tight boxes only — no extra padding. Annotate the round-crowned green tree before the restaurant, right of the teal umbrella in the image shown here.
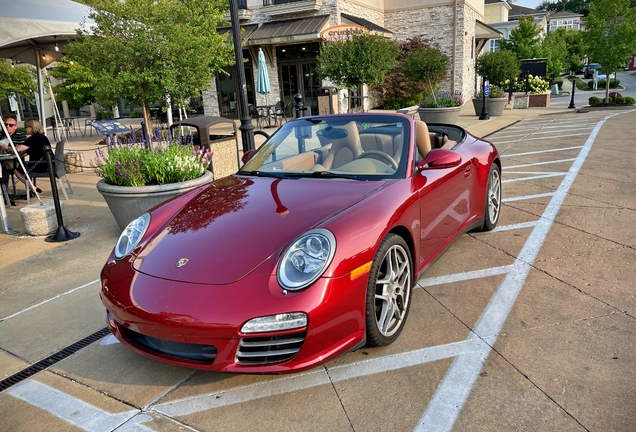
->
[317,32,398,109]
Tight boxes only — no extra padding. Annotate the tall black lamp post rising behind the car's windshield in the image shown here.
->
[230,0,256,153]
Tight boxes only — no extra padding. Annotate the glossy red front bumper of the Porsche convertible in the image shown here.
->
[100,260,367,373]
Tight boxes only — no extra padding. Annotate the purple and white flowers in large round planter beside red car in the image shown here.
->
[94,133,214,230]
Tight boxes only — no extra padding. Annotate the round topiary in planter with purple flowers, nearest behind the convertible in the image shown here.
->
[402,47,464,124]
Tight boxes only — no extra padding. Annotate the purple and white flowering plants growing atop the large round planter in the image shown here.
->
[94,132,212,186]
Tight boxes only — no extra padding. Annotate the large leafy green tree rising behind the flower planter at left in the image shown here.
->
[70,0,234,145]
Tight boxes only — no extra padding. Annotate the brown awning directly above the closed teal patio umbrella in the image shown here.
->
[243,15,329,46]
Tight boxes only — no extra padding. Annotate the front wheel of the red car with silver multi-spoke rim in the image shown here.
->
[366,234,413,346]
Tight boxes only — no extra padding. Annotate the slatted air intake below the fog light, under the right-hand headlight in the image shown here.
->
[236,333,306,365]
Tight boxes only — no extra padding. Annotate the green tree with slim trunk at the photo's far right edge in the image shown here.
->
[584,0,636,103]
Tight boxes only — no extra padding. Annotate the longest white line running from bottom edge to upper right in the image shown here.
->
[415,114,616,432]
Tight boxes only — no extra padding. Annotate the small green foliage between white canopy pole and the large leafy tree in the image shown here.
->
[51,56,96,108]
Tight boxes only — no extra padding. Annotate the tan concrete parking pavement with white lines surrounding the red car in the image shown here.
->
[0,107,636,431]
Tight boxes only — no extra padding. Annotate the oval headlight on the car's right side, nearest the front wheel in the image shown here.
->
[276,228,336,290]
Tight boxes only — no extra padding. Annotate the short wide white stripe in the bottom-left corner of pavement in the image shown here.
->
[8,380,140,432]
